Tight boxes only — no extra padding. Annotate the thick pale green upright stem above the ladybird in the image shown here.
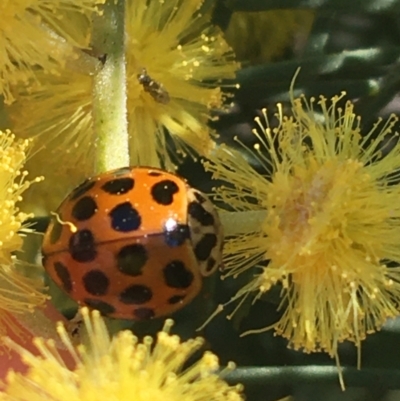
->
[92,0,129,173]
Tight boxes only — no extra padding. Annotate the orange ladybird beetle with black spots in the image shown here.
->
[42,167,223,320]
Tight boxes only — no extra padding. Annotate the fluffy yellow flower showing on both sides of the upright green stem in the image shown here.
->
[9,0,238,191]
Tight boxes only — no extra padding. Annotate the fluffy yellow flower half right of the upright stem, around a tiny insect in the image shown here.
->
[126,0,239,166]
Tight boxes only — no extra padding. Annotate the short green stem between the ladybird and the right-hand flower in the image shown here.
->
[219,210,267,237]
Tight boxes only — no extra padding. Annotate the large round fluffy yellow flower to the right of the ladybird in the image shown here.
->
[207,94,400,372]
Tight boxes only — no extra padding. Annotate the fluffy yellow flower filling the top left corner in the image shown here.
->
[0,0,104,103]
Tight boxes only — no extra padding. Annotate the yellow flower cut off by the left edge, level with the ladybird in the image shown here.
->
[0,131,45,332]
